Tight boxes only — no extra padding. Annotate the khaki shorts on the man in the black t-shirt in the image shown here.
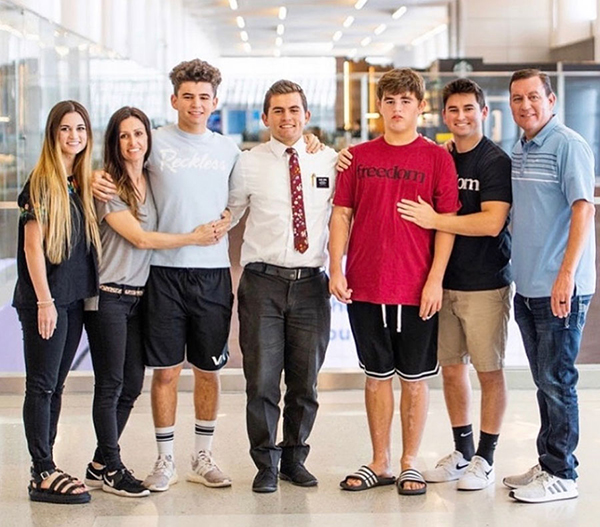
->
[438,285,512,372]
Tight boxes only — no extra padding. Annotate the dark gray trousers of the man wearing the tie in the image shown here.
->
[238,270,331,468]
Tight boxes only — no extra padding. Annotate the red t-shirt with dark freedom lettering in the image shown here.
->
[333,136,460,306]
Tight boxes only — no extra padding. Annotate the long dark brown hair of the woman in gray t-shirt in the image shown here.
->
[104,106,152,220]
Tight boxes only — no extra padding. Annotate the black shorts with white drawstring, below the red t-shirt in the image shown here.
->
[348,301,439,381]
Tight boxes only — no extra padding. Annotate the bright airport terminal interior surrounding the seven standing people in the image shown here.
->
[0,0,600,527]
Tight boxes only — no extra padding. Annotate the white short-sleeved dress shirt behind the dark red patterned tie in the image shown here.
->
[228,138,337,267]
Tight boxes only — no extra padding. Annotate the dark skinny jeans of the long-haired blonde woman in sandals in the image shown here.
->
[17,300,83,474]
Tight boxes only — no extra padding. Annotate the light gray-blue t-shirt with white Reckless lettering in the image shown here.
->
[147,125,240,268]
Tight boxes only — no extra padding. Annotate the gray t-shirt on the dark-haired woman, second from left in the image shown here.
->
[96,189,157,287]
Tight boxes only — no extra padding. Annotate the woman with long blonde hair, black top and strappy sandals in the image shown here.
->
[13,101,100,504]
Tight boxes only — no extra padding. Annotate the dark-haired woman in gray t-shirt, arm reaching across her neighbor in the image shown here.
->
[85,107,226,497]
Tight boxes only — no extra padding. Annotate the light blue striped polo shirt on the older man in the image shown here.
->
[512,116,596,298]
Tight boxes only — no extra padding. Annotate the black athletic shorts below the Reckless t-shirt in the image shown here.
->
[143,266,233,371]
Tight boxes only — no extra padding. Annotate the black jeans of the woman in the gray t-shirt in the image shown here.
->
[85,291,144,470]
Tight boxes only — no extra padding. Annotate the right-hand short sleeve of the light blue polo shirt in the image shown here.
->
[557,138,595,206]
